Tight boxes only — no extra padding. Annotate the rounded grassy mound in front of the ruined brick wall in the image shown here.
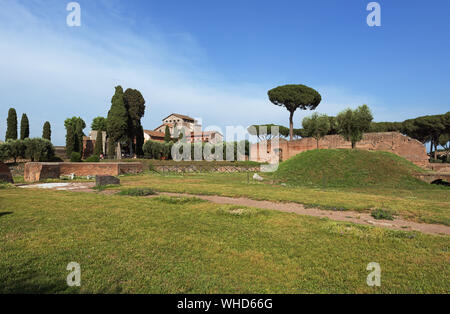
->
[274,149,427,188]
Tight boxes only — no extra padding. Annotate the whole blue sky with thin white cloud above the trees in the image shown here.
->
[0,0,450,145]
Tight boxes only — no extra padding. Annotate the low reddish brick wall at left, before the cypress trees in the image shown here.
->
[24,162,142,182]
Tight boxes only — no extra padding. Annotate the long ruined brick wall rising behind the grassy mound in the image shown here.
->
[250,132,428,167]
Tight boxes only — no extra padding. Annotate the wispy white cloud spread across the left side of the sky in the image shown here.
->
[0,0,380,144]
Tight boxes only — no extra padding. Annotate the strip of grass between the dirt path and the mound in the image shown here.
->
[117,172,450,226]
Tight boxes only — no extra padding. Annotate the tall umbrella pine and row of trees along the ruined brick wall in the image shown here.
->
[248,84,450,159]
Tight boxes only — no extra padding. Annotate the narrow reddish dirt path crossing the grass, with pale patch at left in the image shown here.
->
[19,182,450,235]
